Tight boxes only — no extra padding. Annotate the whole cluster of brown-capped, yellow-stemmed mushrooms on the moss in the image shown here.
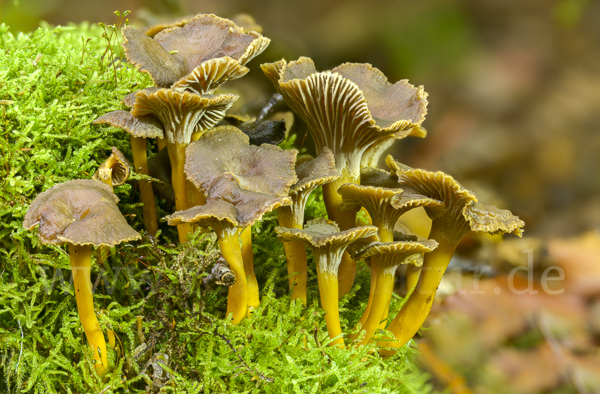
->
[24,15,524,372]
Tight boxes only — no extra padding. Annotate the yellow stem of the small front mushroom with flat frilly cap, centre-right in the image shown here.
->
[317,264,346,348]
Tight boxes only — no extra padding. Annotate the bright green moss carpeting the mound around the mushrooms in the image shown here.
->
[0,24,430,393]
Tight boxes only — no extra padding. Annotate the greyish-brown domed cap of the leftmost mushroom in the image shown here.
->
[23,179,141,247]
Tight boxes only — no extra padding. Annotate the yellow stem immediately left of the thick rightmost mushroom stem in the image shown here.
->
[359,265,397,345]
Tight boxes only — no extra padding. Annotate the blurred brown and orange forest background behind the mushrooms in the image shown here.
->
[0,0,600,393]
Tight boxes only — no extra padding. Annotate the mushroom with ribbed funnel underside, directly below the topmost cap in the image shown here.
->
[131,89,238,243]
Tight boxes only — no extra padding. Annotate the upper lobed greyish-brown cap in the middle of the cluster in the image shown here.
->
[185,126,298,197]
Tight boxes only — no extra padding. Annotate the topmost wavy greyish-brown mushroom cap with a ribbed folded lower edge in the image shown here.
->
[123,14,270,93]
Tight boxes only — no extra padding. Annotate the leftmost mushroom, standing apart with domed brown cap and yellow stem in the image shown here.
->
[23,179,141,374]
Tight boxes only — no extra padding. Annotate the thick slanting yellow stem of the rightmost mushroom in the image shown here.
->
[379,227,462,356]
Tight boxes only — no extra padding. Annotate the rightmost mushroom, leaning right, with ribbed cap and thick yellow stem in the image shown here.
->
[382,169,524,355]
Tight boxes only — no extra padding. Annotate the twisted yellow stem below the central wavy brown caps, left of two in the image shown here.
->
[217,227,248,324]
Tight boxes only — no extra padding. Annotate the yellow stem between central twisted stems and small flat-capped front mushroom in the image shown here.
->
[277,207,307,305]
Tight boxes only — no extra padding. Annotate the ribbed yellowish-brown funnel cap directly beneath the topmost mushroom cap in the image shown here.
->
[131,89,238,144]
